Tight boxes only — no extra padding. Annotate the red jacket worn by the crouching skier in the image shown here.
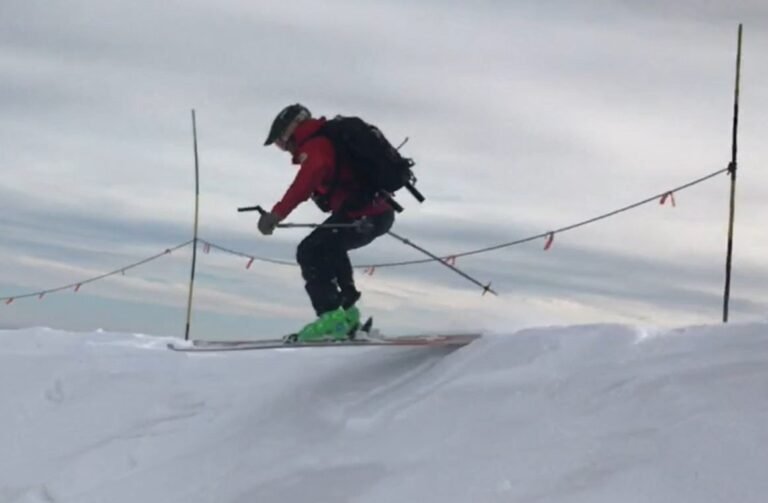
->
[272,117,391,220]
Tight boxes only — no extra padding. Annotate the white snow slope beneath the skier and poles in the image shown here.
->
[0,323,768,503]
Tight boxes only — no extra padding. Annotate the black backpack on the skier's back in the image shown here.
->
[312,115,424,212]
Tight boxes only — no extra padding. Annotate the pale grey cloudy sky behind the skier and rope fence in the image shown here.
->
[0,0,768,338]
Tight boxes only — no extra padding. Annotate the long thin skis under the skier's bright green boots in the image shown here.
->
[168,333,481,353]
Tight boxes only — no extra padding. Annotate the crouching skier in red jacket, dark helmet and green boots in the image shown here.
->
[258,103,395,341]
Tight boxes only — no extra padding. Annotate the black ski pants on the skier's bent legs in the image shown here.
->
[296,210,395,316]
